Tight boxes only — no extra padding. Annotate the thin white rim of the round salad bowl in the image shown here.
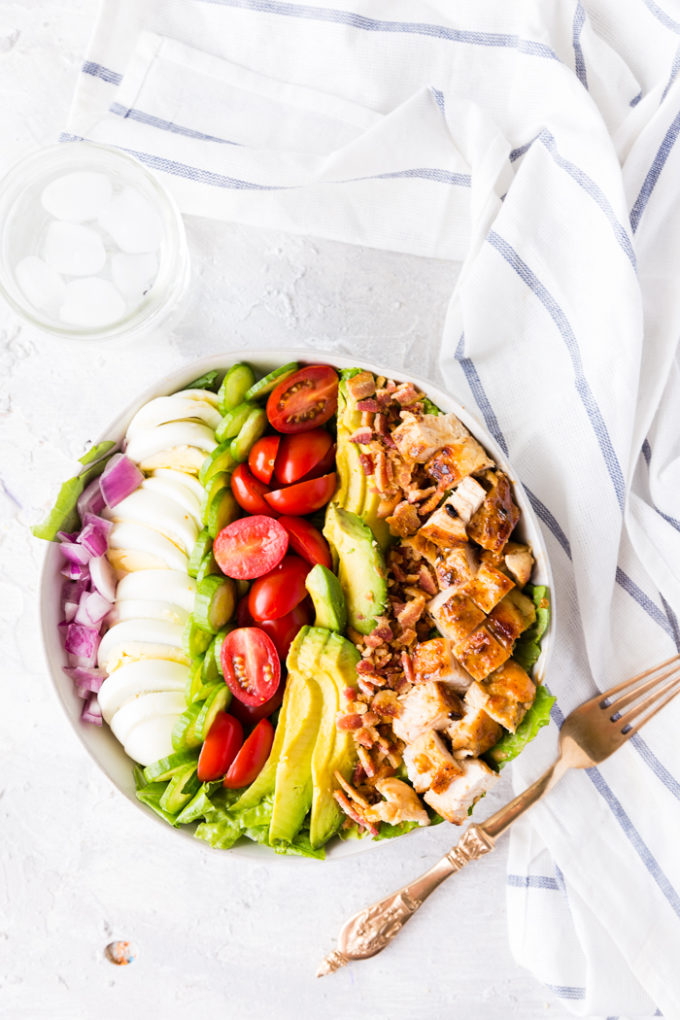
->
[39,348,558,861]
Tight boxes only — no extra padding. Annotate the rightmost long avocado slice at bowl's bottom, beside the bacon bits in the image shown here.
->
[309,633,361,849]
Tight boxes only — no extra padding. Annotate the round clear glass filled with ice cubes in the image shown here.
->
[0,142,189,341]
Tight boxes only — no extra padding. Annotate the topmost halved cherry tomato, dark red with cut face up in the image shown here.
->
[267,365,337,432]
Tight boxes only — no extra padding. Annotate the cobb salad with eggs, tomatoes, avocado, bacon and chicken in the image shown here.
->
[34,362,554,857]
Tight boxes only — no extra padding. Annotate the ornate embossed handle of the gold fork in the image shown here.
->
[316,825,494,977]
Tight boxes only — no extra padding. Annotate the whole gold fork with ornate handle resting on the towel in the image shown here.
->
[316,655,680,977]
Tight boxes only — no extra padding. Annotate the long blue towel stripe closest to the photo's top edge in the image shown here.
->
[195,0,559,60]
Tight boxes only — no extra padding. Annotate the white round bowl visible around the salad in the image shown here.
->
[40,350,556,859]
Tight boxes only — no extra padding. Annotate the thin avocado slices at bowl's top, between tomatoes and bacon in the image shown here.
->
[333,378,391,550]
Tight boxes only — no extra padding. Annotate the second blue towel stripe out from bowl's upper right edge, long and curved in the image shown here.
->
[487,231,626,512]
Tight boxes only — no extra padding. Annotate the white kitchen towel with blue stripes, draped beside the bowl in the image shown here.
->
[64,0,680,1018]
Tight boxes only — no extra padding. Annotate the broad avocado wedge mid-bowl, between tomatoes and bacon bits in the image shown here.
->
[323,503,387,634]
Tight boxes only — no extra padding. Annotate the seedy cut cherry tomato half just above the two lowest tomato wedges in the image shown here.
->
[221,627,281,705]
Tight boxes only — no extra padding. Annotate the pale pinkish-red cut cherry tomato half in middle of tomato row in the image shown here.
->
[212,514,289,580]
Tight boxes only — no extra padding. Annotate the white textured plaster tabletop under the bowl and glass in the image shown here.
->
[0,0,569,1020]
